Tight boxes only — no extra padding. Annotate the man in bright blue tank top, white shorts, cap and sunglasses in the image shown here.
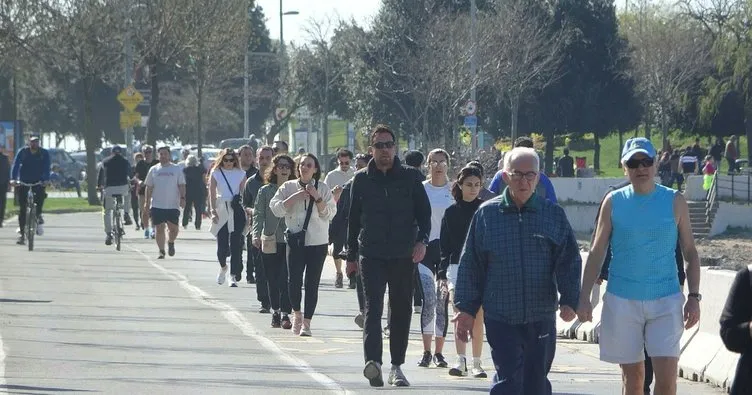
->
[577,137,702,395]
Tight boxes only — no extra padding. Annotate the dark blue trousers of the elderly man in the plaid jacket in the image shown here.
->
[485,318,556,395]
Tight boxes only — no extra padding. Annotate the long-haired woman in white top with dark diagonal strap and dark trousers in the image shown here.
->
[209,148,246,287]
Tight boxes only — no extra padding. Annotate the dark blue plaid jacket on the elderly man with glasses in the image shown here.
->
[455,189,582,325]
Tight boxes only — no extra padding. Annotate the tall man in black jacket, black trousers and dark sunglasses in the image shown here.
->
[347,125,431,387]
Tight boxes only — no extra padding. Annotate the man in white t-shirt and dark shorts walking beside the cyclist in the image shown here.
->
[144,147,185,259]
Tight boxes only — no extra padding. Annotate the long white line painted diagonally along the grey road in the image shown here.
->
[129,246,353,395]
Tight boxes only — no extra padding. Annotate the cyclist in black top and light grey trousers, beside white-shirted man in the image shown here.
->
[97,145,133,245]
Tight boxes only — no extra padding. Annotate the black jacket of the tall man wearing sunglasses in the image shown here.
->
[347,157,431,261]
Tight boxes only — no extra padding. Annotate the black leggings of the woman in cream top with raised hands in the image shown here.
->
[287,244,327,319]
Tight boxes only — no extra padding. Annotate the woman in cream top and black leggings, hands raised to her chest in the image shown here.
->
[269,154,337,336]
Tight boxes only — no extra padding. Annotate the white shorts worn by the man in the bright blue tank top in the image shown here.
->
[599,292,684,364]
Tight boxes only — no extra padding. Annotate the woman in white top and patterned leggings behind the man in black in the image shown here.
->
[418,148,454,368]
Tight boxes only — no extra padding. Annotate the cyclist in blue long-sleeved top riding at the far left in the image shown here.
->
[10,136,51,244]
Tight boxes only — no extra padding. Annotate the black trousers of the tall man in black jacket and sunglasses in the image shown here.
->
[360,257,415,366]
